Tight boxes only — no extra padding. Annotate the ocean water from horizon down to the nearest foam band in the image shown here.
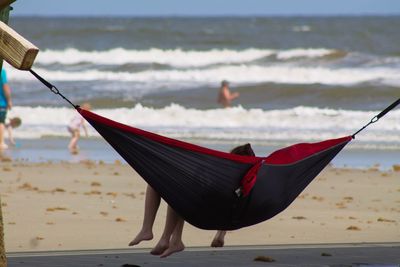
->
[10,17,400,110]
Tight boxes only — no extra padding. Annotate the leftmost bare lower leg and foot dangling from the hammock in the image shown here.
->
[129,185,161,246]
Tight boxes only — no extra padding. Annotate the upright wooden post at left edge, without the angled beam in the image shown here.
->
[0,0,15,267]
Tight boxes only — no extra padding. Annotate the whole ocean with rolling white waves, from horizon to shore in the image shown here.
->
[4,16,400,166]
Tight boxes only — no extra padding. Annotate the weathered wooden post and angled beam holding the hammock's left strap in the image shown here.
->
[0,0,39,267]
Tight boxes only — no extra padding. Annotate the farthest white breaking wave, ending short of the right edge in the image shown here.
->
[32,48,337,67]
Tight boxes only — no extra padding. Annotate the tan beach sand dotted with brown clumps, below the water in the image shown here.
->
[0,160,400,252]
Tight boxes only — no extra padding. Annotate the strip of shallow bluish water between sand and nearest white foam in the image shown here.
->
[3,138,400,171]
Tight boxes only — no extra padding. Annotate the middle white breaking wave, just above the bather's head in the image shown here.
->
[8,65,400,89]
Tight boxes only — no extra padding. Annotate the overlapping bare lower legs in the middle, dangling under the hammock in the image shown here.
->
[150,206,184,256]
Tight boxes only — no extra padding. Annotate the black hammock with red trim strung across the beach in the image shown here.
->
[77,108,352,230]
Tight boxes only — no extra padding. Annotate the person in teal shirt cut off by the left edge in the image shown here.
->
[0,69,12,150]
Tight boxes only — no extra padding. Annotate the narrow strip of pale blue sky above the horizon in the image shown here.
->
[12,0,400,16]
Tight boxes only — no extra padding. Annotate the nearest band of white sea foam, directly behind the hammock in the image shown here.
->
[9,104,400,148]
